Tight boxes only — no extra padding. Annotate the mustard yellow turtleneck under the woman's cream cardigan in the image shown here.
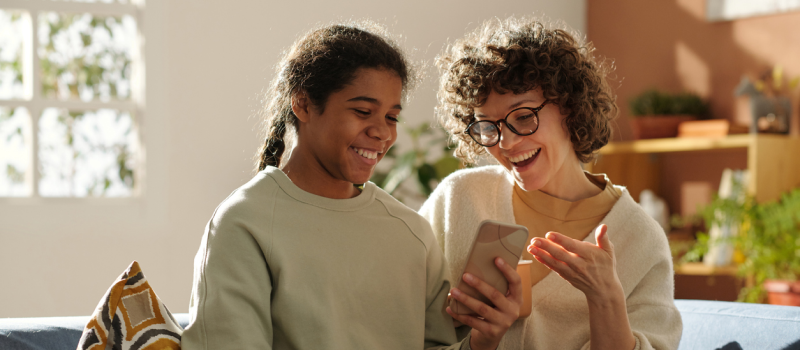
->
[511,173,622,285]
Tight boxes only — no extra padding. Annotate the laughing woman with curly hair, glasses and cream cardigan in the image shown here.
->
[420,19,682,350]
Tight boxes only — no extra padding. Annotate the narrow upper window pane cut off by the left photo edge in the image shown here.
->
[0,10,31,100]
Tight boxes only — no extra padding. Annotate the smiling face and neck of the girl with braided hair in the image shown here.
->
[290,68,403,193]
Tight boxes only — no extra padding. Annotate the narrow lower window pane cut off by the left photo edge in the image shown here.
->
[0,107,33,197]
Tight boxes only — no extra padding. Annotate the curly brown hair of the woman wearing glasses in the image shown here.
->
[436,18,618,163]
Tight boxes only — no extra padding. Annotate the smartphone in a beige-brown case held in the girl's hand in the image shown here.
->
[450,220,528,315]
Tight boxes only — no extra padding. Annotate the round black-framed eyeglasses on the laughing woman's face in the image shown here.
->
[464,100,553,147]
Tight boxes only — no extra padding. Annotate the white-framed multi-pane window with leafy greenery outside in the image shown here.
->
[0,0,144,197]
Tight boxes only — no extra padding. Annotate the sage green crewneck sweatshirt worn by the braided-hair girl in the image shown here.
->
[181,167,469,350]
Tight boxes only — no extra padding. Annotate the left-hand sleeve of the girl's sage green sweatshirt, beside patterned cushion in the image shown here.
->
[181,198,273,350]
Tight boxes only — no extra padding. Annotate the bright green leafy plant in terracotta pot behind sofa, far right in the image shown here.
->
[683,183,800,306]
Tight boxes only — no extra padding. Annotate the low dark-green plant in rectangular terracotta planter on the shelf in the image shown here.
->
[629,89,708,140]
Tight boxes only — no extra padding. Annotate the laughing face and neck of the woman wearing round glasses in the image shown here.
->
[474,88,585,195]
